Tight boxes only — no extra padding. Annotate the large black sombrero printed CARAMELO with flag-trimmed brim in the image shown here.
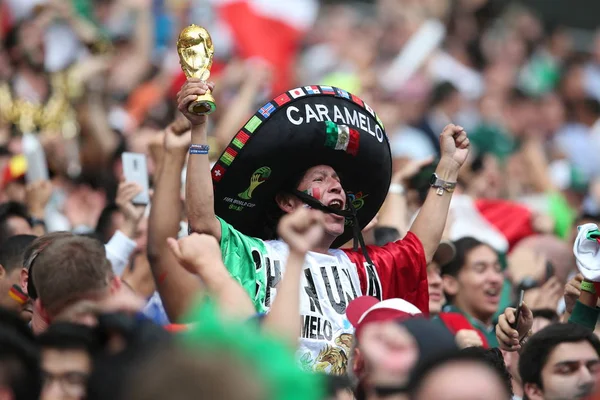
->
[212,86,392,247]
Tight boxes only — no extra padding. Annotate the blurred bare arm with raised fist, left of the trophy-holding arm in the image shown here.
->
[148,121,202,322]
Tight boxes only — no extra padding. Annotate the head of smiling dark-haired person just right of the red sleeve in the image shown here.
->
[442,237,504,347]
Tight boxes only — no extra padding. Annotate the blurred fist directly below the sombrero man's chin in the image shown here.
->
[277,207,324,254]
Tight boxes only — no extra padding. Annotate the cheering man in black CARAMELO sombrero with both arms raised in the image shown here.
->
[178,79,469,373]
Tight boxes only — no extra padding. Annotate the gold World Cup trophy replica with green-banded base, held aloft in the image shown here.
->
[177,25,216,115]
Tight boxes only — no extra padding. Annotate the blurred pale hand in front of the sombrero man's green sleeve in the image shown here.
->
[167,233,223,275]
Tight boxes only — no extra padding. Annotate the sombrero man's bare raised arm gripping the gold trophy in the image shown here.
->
[177,79,221,241]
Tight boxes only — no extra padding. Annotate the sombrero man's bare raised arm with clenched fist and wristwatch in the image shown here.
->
[410,124,470,263]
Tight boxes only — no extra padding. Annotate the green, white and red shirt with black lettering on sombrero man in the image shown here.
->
[220,220,429,375]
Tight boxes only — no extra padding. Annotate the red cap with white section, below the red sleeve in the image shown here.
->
[346,296,422,338]
